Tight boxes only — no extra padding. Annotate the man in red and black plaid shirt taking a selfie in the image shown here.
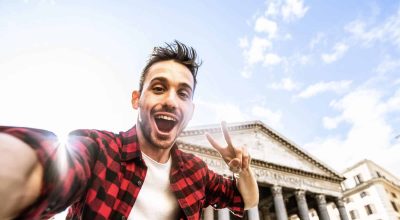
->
[0,41,258,219]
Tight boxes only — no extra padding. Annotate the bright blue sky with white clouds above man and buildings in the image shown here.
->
[0,0,400,180]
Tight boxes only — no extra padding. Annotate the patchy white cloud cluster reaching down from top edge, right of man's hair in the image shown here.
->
[239,0,310,75]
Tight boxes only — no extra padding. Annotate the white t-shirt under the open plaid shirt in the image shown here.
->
[128,152,179,220]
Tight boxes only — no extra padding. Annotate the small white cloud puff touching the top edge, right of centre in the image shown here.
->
[281,0,309,21]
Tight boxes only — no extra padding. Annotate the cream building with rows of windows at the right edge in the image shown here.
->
[342,160,400,220]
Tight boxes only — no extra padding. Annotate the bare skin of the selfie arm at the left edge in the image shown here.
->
[0,133,43,219]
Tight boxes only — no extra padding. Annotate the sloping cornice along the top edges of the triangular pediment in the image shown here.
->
[180,121,345,180]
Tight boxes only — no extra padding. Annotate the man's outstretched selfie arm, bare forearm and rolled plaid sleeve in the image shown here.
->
[0,126,103,219]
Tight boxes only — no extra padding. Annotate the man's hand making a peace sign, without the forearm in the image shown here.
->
[206,121,250,173]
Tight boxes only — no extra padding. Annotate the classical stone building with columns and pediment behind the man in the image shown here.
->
[178,121,348,220]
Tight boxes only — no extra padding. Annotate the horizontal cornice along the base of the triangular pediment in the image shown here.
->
[177,141,344,183]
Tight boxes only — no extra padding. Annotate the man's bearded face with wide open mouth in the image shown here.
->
[132,60,194,149]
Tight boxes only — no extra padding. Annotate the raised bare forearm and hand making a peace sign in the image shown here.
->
[206,122,259,209]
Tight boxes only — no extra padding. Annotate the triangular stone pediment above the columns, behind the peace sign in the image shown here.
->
[179,121,340,178]
